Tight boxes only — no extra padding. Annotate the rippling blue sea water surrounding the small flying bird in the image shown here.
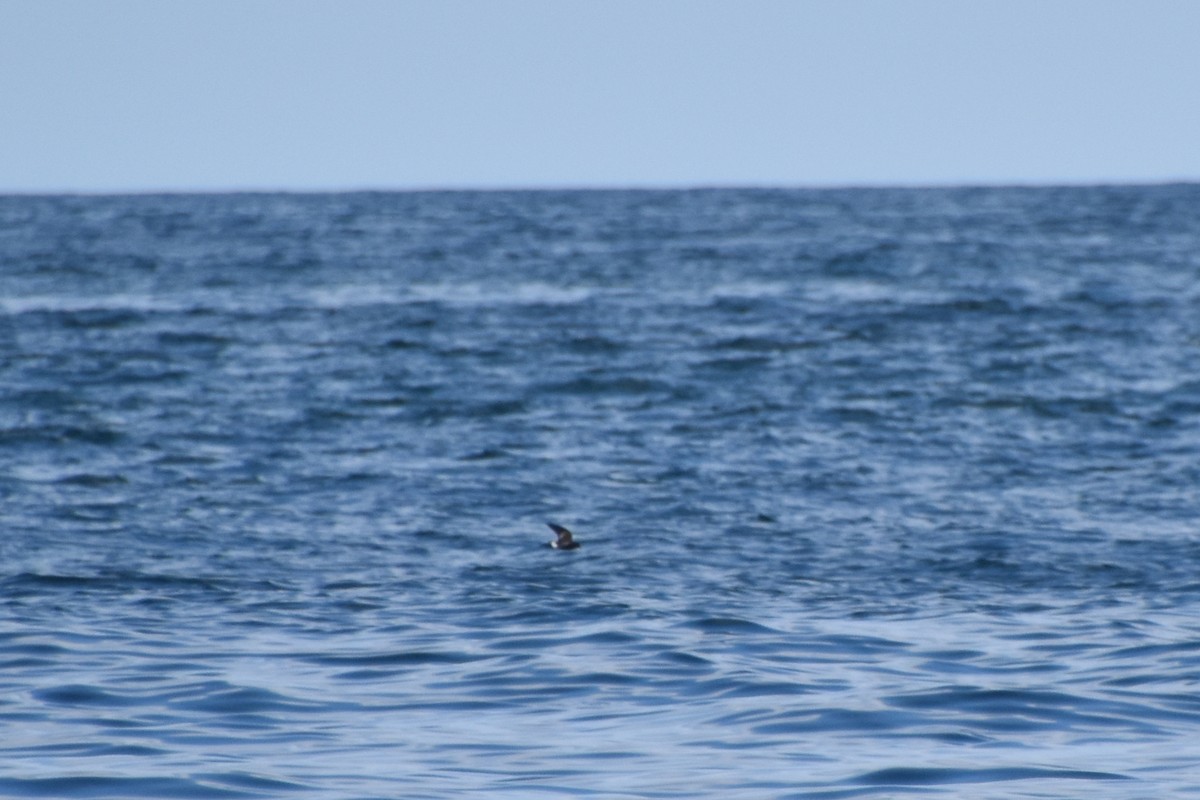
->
[0,185,1200,800]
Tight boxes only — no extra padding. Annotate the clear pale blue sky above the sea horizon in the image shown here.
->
[0,0,1200,193]
